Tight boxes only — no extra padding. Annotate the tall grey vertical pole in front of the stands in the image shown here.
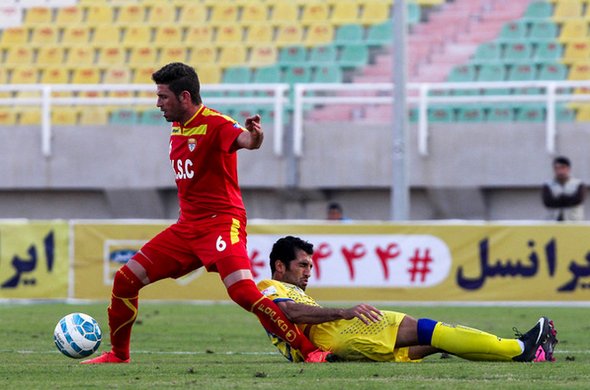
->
[390,0,410,221]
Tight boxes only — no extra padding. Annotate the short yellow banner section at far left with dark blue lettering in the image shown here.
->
[0,221,70,299]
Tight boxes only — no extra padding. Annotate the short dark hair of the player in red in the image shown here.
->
[152,62,202,104]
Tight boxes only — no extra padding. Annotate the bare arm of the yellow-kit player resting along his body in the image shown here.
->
[277,301,381,325]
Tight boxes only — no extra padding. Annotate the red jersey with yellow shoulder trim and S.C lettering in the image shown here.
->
[170,105,247,222]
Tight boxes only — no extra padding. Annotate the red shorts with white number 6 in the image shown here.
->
[133,215,251,282]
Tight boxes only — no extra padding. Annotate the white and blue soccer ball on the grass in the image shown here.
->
[53,313,102,359]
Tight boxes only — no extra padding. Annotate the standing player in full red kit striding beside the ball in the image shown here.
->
[82,62,330,364]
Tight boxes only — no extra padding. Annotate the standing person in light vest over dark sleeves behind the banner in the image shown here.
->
[543,156,586,221]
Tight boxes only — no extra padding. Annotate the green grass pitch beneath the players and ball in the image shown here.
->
[0,303,590,390]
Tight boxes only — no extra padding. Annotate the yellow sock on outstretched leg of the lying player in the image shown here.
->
[431,322,522,361]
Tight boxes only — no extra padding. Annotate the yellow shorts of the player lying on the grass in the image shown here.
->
[309,311,411,362]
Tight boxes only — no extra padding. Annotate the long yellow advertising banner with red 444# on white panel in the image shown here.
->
[72,221,590,302]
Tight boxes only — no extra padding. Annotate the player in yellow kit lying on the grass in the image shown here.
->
[258,236,557,362]
